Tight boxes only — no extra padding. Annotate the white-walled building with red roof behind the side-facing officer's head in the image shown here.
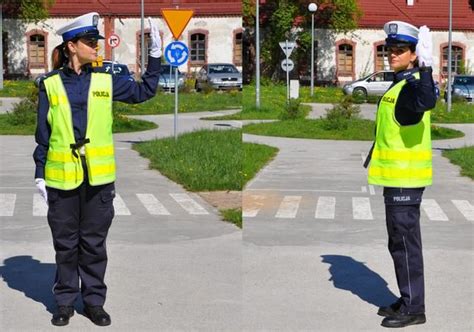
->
[312,0,474,84]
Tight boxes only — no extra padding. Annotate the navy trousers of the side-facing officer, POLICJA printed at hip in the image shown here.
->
[383,187,425,314]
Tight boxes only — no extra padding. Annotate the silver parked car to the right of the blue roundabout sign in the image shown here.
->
[195,63,242,91]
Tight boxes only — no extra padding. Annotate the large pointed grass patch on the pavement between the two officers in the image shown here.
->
[133,129,278,191]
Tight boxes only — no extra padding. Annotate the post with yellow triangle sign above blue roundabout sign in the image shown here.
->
[161,9,194,141]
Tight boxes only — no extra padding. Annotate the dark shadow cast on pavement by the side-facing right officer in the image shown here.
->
[321,255,397,307]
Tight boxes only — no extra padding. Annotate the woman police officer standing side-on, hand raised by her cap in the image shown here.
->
[365,21,436,327]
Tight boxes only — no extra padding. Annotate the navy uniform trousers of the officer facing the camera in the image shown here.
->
[47,157,115,306]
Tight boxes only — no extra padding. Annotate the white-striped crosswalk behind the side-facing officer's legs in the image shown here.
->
[242,193,474,222]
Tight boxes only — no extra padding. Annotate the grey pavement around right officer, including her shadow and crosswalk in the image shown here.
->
[243,109,474,331]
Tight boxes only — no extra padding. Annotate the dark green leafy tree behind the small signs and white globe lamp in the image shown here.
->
[243,0,362,79]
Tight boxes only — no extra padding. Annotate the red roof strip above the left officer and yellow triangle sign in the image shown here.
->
[49,0,242,17]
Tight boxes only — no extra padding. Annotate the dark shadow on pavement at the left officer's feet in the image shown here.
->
[0,256,56,313]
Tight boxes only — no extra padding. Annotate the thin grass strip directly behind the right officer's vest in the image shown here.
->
[243,119,464,141]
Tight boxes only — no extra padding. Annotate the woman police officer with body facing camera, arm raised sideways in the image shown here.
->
[33,13,162,326]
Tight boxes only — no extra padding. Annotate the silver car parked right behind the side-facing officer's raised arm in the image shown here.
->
[342,70,394,98]
